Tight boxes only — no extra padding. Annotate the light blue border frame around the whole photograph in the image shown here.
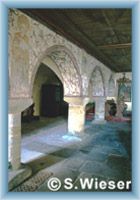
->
[0,0,140,200]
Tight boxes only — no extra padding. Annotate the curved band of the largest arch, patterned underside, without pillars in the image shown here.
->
[30,45,82,96]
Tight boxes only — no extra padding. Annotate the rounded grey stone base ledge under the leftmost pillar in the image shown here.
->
[8,166,32,191]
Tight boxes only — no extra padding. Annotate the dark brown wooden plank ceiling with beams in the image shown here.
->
[20,9,132,72]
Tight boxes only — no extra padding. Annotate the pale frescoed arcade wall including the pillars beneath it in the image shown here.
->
[8,9,131,169]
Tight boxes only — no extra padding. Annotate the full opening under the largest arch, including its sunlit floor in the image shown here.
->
[21,64,68,163]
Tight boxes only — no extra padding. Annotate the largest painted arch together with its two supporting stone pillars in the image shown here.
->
[9,45,84,169]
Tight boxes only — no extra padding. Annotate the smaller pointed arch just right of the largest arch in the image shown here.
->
[88,66,105,97]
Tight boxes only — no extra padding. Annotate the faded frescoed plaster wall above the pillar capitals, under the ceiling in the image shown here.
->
[9,10,111,98]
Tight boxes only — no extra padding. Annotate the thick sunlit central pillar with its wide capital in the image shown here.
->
[64,97,88,134]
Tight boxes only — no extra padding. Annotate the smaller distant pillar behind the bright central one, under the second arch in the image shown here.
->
[93,97,105,121]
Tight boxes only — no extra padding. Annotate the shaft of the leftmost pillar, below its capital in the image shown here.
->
[8,113,21,170]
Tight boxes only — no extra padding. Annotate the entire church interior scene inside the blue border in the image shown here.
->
[8,8,132,192]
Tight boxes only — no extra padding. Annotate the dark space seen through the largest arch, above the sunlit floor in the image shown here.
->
[21,63,68,134]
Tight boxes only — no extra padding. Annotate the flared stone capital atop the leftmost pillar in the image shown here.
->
[9,98,33,114]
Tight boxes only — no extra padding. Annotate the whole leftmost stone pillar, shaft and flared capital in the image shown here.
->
[8,98,32,170]
